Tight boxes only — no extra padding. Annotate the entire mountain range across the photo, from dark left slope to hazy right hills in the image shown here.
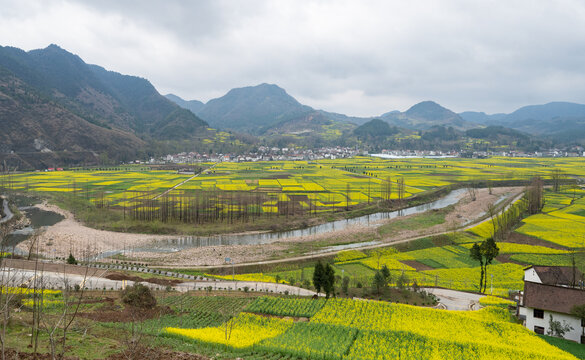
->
[0,45,585,167]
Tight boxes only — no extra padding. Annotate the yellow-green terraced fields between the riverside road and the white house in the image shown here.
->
[203,189,585,297]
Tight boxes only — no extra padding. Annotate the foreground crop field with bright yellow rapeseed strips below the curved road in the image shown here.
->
[7,291,581,360]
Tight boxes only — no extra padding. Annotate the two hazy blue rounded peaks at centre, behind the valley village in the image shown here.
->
[166,84,478,135]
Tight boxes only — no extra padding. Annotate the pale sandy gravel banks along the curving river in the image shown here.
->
[18,187,524,266]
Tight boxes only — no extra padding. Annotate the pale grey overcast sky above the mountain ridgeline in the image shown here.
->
[0,0,585,116]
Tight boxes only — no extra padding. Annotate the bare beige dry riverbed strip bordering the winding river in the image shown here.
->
[18,187,524,267]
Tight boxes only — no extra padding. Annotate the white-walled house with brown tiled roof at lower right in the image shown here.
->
[518,266,585,343]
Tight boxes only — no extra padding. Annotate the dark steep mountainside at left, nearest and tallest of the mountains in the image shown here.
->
[0,45,208,165]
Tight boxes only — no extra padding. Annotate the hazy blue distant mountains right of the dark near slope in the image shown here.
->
[166,84,585,141]
